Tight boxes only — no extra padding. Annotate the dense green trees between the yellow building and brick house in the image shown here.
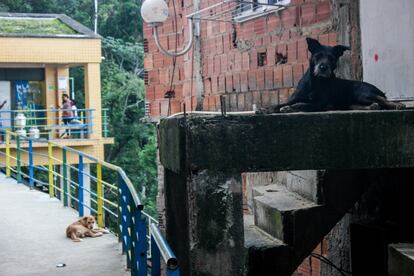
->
[0,0,157,215]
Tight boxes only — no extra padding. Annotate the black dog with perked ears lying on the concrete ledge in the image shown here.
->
[258,38,405,113]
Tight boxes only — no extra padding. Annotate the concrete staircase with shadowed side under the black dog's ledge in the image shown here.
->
[244,170,364,276]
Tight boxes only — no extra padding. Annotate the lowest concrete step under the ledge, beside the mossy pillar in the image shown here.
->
[244,215,299,276]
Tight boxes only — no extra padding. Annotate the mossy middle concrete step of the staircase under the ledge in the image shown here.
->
[253,184,323,246]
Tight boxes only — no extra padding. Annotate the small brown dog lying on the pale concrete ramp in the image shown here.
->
[66,216,109,242]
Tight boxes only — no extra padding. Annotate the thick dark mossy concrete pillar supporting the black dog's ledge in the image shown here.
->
[165,170,244,276]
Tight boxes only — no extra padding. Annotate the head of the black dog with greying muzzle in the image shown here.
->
[306,38,350,78]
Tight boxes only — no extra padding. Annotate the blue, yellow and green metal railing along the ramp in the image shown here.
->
[0,129,180,276]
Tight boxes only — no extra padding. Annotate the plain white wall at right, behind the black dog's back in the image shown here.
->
[360,0,414,99]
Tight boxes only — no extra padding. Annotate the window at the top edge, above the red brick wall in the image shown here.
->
[235,0,290,22]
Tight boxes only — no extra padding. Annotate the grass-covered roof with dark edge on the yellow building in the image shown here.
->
[0,13,100,38]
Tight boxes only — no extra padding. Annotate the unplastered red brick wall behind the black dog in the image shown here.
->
[144,0,337,118]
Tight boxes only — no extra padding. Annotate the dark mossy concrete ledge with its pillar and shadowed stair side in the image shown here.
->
[159,110,414,275]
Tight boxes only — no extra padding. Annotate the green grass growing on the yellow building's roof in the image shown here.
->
[0,17,77,35]
